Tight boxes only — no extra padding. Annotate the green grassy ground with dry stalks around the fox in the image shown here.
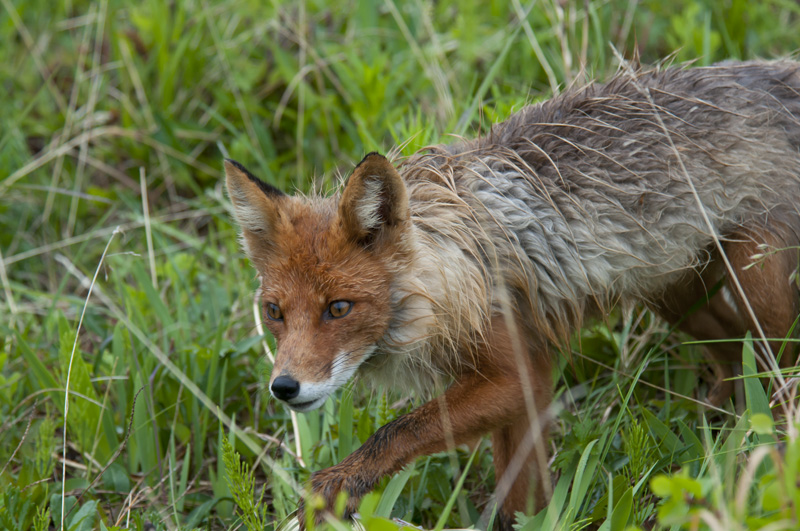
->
[0,0,800,530]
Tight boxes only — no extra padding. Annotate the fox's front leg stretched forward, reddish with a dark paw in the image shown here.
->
[300,319,552,522]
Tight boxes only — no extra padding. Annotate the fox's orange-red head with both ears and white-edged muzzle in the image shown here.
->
[225,153,410,411]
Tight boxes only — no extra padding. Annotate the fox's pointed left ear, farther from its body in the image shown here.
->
[225,159,286,239]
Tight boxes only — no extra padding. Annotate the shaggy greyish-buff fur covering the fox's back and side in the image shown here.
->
[400,61,800,336]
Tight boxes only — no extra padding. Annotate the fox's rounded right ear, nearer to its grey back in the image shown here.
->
[339,153,409,241]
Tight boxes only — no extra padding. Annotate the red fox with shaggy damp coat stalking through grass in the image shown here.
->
[225,60,800,528]
